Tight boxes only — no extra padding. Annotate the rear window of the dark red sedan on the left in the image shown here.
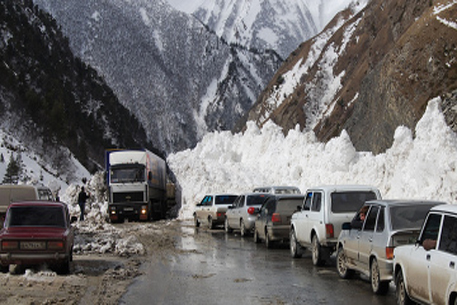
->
[6,206,65,228]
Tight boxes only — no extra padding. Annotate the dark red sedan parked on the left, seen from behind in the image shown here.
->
[0,201,75,274]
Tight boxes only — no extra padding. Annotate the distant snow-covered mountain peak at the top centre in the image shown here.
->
[191,0,366,58]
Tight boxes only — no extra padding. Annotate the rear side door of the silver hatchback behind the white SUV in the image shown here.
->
[357,205,379,270]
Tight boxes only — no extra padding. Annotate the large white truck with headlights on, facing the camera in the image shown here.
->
[105,149,168,222]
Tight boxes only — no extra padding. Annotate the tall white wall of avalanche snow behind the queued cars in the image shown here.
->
[168,98,457,219]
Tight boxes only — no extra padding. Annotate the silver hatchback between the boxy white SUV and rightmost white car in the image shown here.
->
[336,200,443,294]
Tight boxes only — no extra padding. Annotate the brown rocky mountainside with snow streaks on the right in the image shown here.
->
[237,0,457,153]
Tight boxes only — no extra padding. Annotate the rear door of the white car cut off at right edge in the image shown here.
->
[428,215,457,304]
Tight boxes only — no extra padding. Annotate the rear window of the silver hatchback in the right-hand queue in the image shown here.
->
[390,204,434,231]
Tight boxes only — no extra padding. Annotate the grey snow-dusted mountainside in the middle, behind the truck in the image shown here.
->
[35,0,282,153]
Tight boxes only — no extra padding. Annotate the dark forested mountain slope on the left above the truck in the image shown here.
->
[0,0,153,177]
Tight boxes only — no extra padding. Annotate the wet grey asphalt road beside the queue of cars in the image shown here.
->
[120,222,395,305]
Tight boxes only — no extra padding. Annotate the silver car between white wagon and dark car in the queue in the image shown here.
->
[224,193,274,236]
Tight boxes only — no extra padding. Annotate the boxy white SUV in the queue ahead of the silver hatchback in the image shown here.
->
[290,185,381,266]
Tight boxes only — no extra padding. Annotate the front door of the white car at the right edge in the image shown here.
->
[407,213,442,303]
